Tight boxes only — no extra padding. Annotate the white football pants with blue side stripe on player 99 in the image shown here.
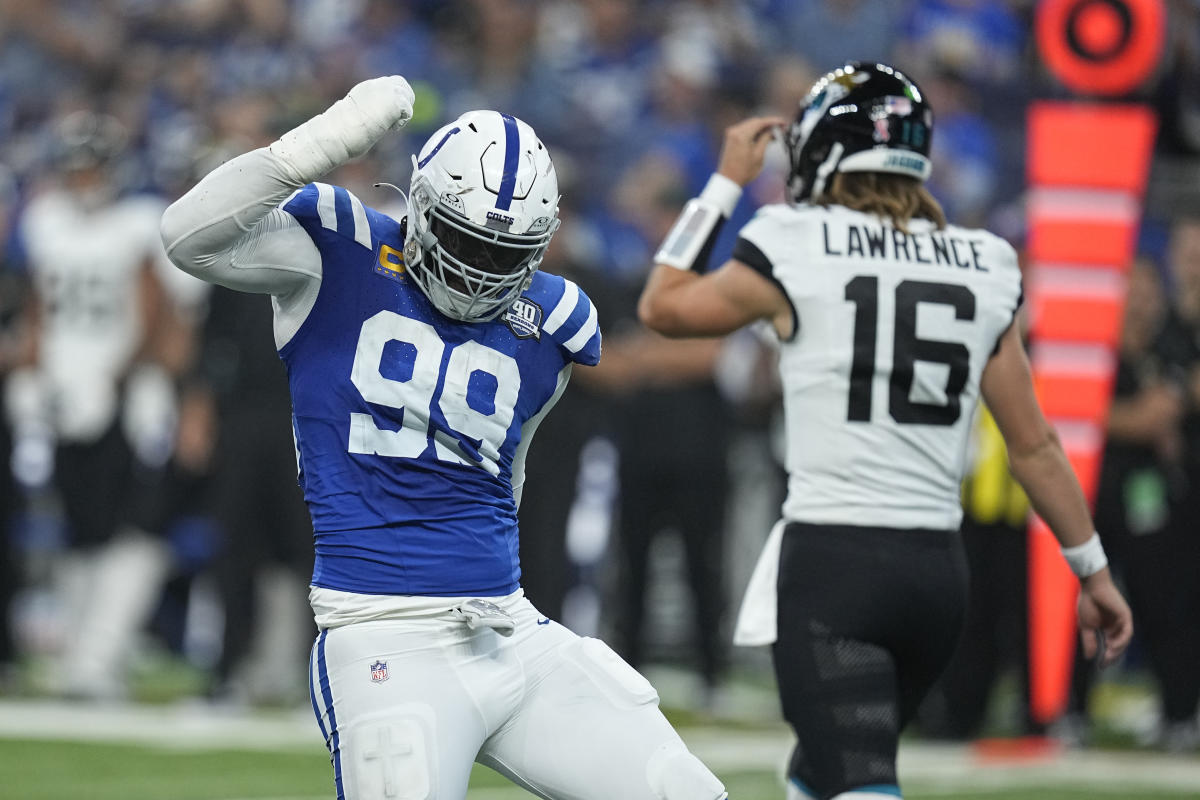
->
[310,597,725,800]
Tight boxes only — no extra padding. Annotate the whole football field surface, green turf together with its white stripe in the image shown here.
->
[0,681,1200,800]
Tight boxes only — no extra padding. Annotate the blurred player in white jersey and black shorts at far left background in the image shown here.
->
[8,110,203,699]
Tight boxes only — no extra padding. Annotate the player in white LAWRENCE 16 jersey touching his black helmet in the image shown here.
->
[638,64,1133,800]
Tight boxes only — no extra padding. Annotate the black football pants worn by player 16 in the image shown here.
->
[774,523,967,800]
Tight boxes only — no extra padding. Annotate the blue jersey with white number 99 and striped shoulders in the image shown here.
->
[280,184,600,596]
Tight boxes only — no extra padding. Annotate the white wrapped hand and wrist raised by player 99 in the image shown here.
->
[270,76,414,186]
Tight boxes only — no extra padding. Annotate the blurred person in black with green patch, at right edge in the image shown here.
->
[1096,258,1200,751]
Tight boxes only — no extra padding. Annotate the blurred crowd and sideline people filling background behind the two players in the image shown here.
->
[0,0,1200,748]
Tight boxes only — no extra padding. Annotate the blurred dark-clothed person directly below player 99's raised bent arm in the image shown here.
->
[188,287,316,704]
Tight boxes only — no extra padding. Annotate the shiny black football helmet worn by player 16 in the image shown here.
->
[787,61,934,203]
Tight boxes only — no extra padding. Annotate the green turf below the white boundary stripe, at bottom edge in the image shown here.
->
[0,739,1200,800]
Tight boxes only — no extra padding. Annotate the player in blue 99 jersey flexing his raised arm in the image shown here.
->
[162,77,726,800]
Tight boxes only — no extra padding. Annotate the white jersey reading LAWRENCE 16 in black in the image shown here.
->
[733,205,1021,529]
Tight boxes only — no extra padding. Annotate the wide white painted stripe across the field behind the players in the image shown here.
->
[0,700,1200,800]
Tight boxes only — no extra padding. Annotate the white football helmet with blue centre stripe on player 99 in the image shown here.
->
[404,110,559,323]
